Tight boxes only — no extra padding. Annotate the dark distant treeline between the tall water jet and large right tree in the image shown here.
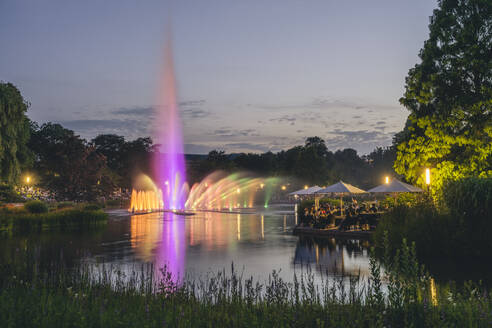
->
[188,137,396,188]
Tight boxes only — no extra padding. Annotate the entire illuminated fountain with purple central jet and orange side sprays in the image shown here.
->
[129,39,276,214]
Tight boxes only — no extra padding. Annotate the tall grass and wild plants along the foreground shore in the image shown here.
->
[0,242,492,327]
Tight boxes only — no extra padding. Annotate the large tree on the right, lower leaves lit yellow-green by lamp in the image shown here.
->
[394,0,492,195]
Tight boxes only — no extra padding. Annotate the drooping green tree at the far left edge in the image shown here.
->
[0,82,30,184]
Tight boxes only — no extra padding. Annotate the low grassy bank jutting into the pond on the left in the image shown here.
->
[0,208,108,232]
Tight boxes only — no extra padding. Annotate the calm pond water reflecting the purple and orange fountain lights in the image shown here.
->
[0,204,369,280]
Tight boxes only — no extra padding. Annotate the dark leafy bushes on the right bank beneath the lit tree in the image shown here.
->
[374,178,492,260]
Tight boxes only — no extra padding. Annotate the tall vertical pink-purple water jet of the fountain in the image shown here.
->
[153,37,186,209]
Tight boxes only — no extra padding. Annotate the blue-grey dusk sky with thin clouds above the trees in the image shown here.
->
[0,0,437,154]
